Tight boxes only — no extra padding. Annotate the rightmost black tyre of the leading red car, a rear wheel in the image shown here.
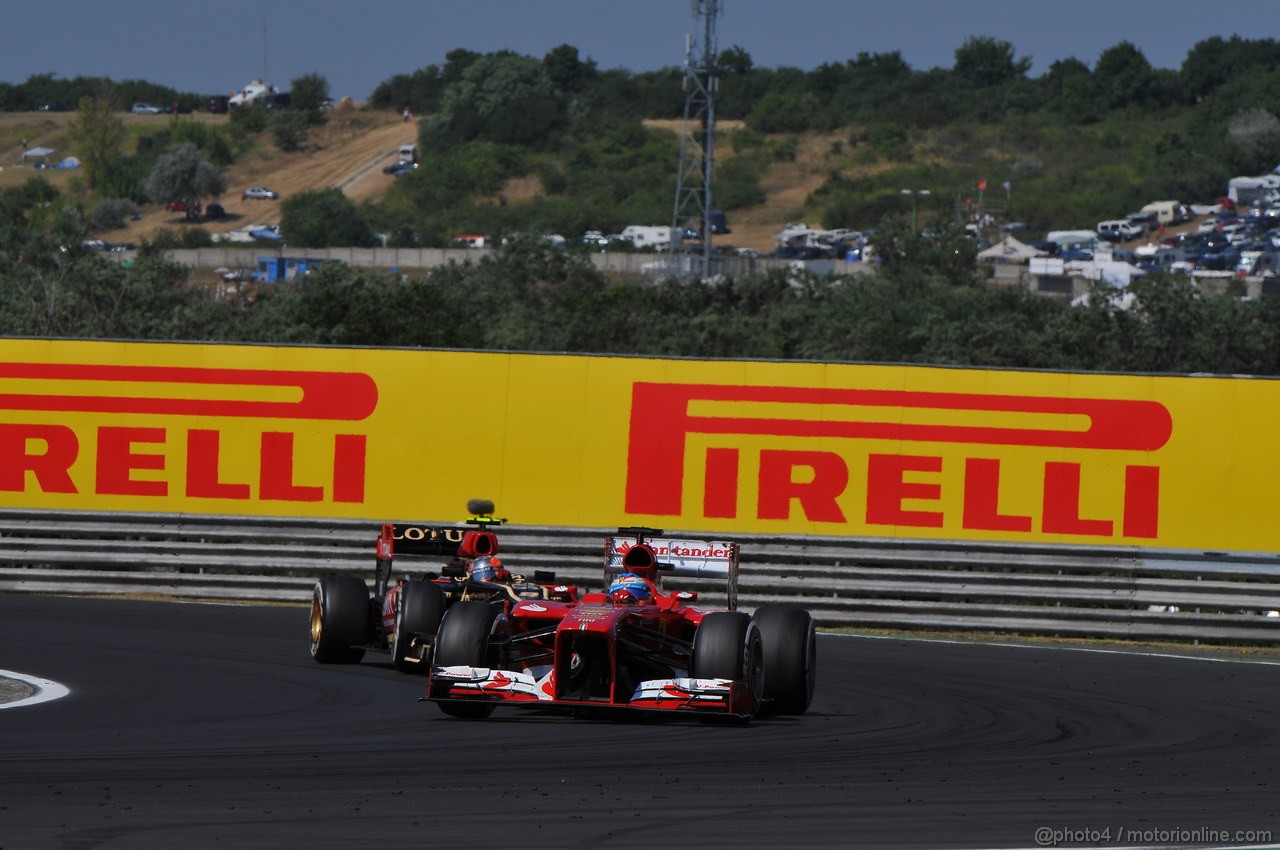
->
[755,605,818,714]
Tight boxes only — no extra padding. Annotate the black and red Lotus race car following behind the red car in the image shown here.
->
[311,499,577,673]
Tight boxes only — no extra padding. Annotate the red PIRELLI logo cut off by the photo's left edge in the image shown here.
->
[0,362,378,503]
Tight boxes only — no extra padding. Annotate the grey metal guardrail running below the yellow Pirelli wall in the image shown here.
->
[0,509,1280,645]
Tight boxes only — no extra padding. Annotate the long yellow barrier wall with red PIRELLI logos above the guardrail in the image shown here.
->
[0,339,1280,552]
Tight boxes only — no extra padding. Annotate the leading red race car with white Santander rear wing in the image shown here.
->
[425,529,817,722]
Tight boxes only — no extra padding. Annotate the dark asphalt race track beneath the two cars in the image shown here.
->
[0,595,1280,850]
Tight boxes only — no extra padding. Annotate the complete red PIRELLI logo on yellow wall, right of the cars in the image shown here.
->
[626,381,1172,539]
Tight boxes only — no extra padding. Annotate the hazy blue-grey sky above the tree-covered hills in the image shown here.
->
[0,0,1280,100]
